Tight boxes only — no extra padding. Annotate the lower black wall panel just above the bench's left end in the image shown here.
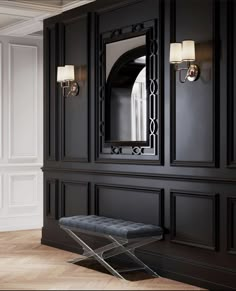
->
[61,182,90,217]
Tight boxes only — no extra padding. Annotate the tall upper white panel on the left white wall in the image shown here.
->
[8,44,38,161]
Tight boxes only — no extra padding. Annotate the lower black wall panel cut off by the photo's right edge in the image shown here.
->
[227,197,236,255]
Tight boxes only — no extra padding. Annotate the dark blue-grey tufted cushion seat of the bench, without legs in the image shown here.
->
[59,215,163,239]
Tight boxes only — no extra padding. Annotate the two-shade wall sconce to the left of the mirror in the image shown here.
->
[57,65,79,97]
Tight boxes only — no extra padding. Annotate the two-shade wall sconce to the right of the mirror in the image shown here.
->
[170,40,200,83]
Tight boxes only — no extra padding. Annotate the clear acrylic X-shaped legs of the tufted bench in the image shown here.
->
[60,225,162,280]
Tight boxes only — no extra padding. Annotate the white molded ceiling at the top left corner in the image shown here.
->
[0,0,95,38]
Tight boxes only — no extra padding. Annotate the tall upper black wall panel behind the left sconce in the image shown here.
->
[61,15,90,162]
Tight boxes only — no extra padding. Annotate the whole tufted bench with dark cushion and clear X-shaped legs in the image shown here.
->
[59,215,163,279]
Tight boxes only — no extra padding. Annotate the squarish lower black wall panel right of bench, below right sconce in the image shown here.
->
[170,191,219,250]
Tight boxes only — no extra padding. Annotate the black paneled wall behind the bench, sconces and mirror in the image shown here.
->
[42,0,236,289]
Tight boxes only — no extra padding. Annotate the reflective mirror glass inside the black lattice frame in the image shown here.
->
[105,35,148,145]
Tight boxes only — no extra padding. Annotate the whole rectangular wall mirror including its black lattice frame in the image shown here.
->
[97,20,162,164]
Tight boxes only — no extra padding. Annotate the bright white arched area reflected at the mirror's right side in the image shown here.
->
[131,67,147,141]
